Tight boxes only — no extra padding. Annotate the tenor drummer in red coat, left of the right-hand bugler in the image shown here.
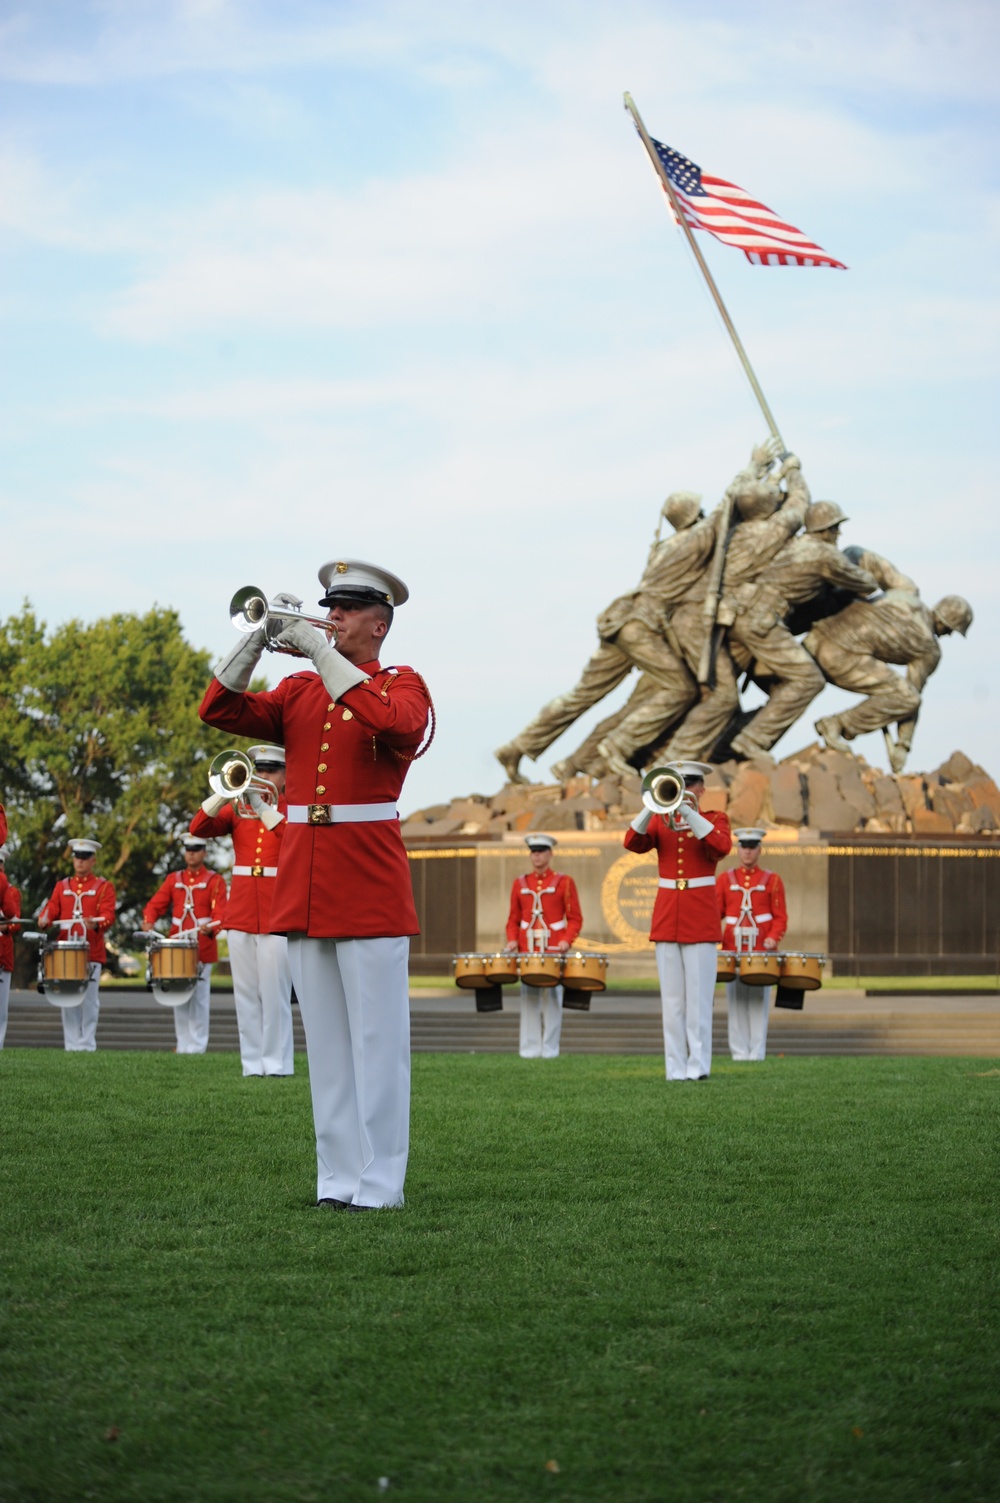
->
[507,834,583,1060]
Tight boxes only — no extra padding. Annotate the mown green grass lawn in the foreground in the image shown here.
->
[0,1051,1000,1503]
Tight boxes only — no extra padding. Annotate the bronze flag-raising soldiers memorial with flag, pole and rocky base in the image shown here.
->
[403,95,1000,971]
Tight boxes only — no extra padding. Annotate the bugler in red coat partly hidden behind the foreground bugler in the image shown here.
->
[191,745,295,1075]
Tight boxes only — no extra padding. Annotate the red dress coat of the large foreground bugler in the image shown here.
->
[198,661,430,939]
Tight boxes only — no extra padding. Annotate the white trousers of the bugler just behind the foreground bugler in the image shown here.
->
[229,929,288,1075]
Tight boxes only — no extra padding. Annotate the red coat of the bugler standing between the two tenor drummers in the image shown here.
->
[626,812,732,944]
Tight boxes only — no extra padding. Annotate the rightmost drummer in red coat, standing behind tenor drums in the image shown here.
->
[716,828,788,1063]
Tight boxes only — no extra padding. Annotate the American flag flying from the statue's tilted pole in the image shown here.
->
[653,141,847,271]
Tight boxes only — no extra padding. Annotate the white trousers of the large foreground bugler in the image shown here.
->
[289,935,409,1205]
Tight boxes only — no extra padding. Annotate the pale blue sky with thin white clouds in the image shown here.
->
[0,0,1000,810]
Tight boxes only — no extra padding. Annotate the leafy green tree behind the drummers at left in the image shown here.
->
[0,603,259,933]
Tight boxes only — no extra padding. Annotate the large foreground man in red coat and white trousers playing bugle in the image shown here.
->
[200,559,433,1210]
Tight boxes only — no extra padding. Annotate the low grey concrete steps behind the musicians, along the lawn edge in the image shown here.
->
[6,1003,1000,1058]
